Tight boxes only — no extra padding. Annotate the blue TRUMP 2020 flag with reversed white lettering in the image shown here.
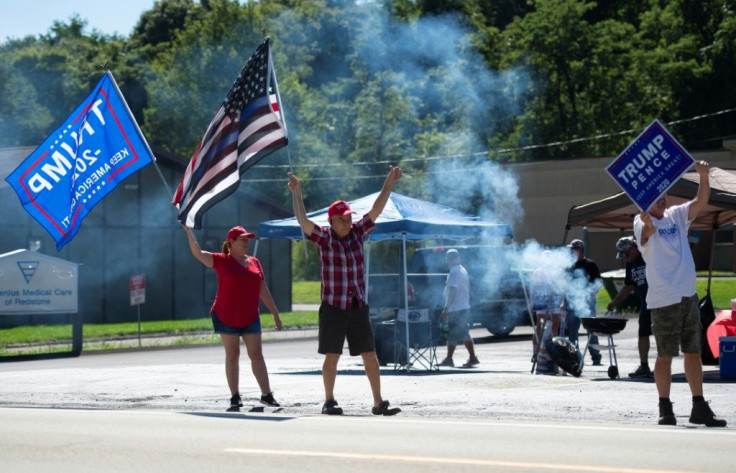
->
[5,71,153,250]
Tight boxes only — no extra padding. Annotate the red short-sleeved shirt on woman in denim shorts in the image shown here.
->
[212,253,263,328]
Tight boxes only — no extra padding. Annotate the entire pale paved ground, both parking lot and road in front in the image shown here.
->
[0,321,736,473]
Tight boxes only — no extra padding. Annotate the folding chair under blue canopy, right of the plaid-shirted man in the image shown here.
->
[394,309,439,371]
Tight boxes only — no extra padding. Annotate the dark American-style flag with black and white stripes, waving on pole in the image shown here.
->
[172,38,288,228]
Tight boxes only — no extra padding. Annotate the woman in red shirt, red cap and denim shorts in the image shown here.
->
[184,226,282,410]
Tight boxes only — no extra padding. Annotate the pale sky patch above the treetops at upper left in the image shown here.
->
[0,0,154,43]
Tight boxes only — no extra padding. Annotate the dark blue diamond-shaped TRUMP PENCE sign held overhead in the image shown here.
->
[606,120,695,212]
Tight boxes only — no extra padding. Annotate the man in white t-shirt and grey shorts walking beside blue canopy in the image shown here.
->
[440,248,480,368]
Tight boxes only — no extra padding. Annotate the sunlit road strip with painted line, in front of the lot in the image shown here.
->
[0,408,736,473]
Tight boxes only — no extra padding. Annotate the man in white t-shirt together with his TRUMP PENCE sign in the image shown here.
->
[606,120,726,427]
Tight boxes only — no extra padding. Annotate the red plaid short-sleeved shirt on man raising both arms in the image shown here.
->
[309,214,376,310]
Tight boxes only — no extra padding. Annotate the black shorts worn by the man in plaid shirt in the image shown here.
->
[317,302,376,356]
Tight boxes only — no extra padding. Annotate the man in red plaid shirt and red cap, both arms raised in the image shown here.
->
[288,166,401,416]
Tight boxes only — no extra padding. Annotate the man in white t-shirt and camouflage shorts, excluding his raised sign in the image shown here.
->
[634,161,726,427]
